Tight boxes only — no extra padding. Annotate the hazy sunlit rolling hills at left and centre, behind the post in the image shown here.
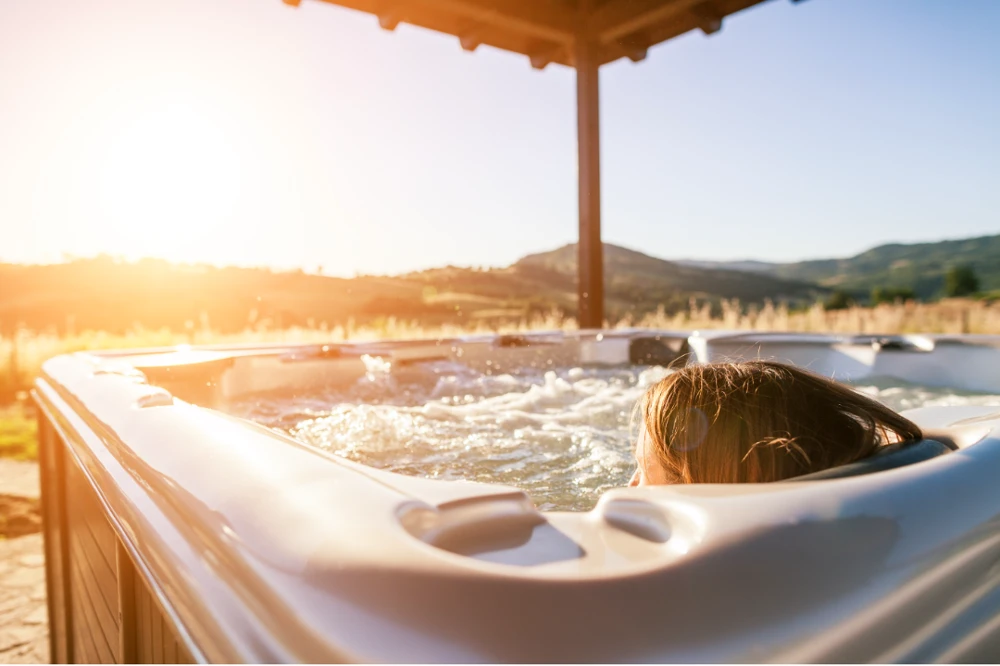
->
[0,245,825,334]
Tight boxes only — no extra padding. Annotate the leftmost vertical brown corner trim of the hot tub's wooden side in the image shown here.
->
[38,410,73,664]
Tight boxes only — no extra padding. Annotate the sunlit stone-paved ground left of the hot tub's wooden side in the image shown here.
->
[0,458,49,664]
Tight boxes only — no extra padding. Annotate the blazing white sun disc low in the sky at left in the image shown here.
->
[97,103,241,261]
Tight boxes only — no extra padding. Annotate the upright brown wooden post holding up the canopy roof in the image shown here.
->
[573,0,604,328]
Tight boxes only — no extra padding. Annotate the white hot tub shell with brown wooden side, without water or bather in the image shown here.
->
[35,330,1000,663]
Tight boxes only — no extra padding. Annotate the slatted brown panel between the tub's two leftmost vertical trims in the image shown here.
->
[64,457,120,663]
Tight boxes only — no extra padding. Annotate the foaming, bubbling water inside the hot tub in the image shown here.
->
[228,357,1000,511]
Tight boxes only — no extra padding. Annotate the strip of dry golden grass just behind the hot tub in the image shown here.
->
[7,299,1000,400]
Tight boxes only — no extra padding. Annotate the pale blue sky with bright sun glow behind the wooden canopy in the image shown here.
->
[0,0,1000,275]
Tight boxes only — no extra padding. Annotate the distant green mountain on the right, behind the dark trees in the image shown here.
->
[678,235,1000,299]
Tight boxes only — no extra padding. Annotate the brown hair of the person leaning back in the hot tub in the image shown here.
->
[637,361,923,483]
